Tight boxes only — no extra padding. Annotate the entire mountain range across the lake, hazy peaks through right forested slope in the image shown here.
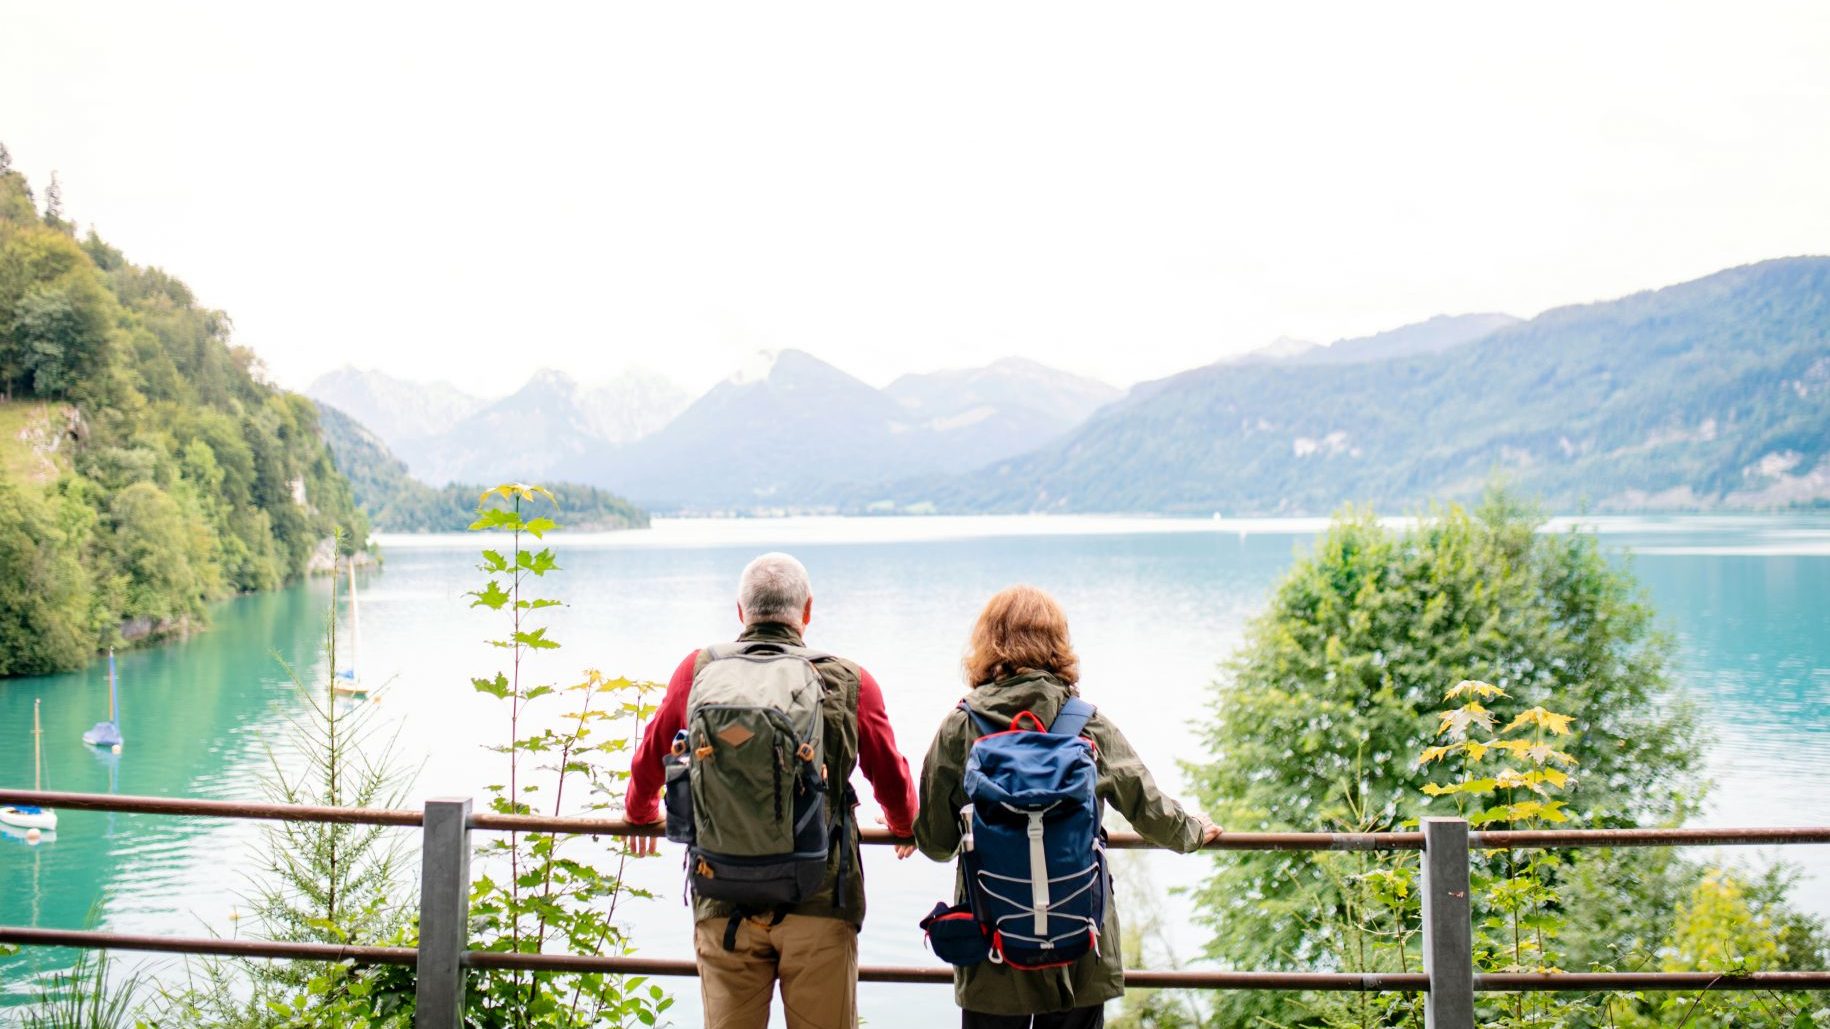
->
[309,256,1830,515]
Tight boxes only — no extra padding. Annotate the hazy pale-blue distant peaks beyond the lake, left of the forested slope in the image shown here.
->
[306,350,1122,511]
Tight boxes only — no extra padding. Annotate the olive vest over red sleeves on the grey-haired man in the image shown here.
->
[692,623,864,926]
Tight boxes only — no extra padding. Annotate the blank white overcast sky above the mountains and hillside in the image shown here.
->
[0,0,1830,394]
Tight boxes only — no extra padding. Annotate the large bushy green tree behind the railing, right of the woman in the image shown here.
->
[1190,493,1700,1025]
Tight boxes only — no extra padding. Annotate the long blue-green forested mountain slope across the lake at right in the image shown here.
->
[896,258,1830,515]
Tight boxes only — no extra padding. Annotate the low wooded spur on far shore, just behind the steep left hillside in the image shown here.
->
[318,403,648,533]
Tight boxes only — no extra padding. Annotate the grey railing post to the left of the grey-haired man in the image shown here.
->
[414,796,470,1029]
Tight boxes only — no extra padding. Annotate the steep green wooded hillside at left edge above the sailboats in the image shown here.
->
[0,148,368,676]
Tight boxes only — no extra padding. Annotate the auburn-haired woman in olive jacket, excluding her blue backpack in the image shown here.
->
[915,586,1221,1029]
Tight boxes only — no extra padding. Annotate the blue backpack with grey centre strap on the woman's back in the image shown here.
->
[959,698,1111,969]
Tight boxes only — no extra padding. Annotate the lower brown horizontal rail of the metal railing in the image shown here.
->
[0,926,1830,992]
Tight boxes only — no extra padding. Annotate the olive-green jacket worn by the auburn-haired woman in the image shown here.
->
[915,670,1202,1014]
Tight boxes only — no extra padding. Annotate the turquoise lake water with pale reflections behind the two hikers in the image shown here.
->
[0,516,1830,1027]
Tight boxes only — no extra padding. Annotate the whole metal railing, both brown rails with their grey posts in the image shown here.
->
[0,789,1830,1029]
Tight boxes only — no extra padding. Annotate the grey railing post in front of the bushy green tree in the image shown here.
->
[1424,818,1475,1029]
